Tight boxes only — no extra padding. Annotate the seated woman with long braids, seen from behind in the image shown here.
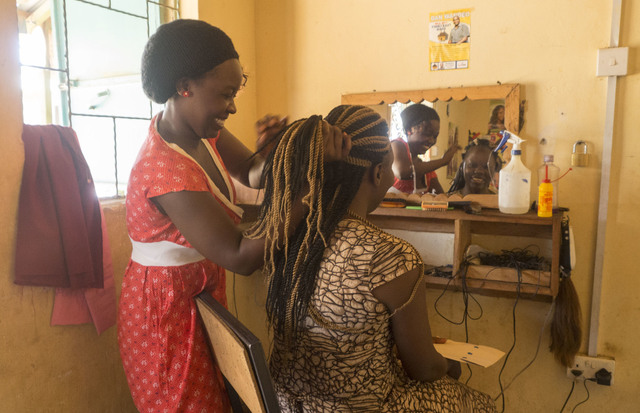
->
[249,105,495,412]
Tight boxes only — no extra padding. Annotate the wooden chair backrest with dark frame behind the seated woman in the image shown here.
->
[196,292,280,413]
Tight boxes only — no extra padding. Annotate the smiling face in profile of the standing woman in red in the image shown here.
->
[184,59,244,138]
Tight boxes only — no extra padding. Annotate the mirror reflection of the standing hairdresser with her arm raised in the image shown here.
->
[391,104,460,194]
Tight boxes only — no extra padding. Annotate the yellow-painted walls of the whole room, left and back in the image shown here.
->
[0,0,640,412]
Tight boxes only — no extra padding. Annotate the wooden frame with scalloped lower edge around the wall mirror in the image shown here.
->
[342,83,520,133]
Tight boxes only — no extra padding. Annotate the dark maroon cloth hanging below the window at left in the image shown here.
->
[15,125,104,288]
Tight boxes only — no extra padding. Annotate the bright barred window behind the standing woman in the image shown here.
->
[17,0,179,197]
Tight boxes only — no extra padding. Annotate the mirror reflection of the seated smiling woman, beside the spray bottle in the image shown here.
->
[447,138,502,196]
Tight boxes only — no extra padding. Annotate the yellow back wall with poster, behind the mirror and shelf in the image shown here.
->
[250,0,640,412]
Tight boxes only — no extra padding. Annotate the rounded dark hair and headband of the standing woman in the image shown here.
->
[141,19,238,103]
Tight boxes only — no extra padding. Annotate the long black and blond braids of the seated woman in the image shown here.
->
[247,105,391,342]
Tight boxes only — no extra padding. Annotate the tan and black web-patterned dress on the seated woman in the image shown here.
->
[270,219,495,413]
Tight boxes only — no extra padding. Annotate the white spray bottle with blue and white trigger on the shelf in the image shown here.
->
[496,131,531,214]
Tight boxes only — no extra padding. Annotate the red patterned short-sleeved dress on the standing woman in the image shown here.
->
[118,115,242,413]
